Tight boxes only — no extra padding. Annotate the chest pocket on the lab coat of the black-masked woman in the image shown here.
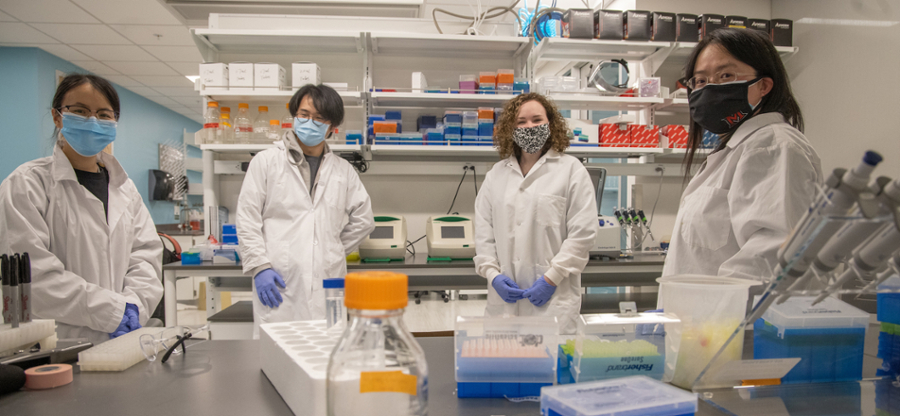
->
[680,186,732,251]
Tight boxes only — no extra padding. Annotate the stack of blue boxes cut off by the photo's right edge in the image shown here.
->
[877,276,900,380]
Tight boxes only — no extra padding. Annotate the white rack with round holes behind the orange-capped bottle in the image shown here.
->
[259,320,341,416]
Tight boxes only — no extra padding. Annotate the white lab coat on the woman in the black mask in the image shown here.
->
[663,113,822,280]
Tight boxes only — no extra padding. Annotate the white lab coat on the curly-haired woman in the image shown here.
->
[474,150,599,334]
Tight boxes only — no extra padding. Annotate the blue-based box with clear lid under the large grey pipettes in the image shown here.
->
[753,296,869,384]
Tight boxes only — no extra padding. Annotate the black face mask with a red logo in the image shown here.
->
[688,77,763,134]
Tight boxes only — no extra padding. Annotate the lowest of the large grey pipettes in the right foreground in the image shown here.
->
[812,222,900,305]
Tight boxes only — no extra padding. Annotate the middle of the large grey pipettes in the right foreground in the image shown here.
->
[778,176,900,304]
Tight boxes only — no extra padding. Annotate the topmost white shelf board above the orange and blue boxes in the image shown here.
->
[369,32,530,59]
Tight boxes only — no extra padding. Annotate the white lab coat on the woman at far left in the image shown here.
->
[0,146,163,344]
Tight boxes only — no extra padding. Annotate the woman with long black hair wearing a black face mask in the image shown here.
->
[663,29,822,280]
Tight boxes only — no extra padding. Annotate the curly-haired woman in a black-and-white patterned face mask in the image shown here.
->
[474,93,599,334]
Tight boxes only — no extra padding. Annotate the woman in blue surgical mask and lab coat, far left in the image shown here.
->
[0,75,163,344]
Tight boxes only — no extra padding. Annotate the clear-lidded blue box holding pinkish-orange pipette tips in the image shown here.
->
[454,316,559,398]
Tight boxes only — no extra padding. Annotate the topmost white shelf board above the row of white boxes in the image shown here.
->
[191,29,365,55]
